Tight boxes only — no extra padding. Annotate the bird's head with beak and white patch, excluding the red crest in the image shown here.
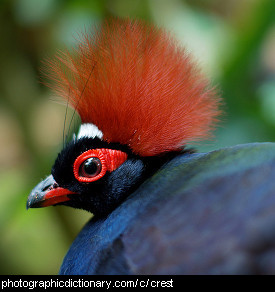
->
[27,124,177,216]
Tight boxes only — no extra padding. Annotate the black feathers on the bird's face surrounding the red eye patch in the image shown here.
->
[52,137,187,216]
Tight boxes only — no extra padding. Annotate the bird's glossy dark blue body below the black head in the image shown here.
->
[60,143,275,275]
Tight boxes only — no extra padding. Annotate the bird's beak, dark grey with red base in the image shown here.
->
[27,175,75,209]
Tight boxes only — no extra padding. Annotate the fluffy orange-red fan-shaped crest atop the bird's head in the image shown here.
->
[45,20,222,156]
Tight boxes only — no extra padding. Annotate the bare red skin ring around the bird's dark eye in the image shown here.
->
[73,148,127,183]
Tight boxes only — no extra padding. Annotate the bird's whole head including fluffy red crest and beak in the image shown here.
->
[27,19,220,216]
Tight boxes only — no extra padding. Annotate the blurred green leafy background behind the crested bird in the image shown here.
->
[0,0,275,274]
